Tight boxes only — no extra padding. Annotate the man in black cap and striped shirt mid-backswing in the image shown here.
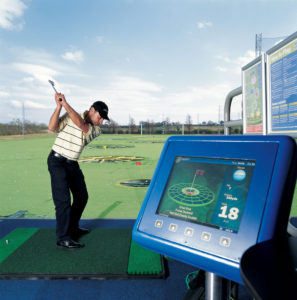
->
[47,93,109,249]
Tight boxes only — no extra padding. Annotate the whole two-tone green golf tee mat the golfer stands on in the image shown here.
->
[0,228,165,279]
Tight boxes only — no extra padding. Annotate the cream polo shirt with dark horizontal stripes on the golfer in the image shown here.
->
[52,111,101,161]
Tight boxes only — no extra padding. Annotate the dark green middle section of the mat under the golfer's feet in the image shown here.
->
[0,228,161,279]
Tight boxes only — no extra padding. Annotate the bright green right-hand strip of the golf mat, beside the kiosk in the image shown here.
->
[128,240,163,275]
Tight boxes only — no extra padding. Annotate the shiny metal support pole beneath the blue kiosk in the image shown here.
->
[205,272,231,300]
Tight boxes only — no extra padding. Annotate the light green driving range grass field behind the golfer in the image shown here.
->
[0,135,297,218]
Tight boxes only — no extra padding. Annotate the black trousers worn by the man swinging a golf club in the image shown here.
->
[47,151,88,241]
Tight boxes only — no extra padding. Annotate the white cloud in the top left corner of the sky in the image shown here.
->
[0,0,27,30]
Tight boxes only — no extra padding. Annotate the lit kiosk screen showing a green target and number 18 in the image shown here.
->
[157,156,255,233]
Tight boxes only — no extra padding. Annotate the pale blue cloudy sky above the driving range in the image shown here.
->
[0,0,297,125]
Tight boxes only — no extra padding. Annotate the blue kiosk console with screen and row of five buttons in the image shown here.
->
[132,136,296,284]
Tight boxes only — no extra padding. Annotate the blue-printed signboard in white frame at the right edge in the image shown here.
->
[267,33,297,136]
